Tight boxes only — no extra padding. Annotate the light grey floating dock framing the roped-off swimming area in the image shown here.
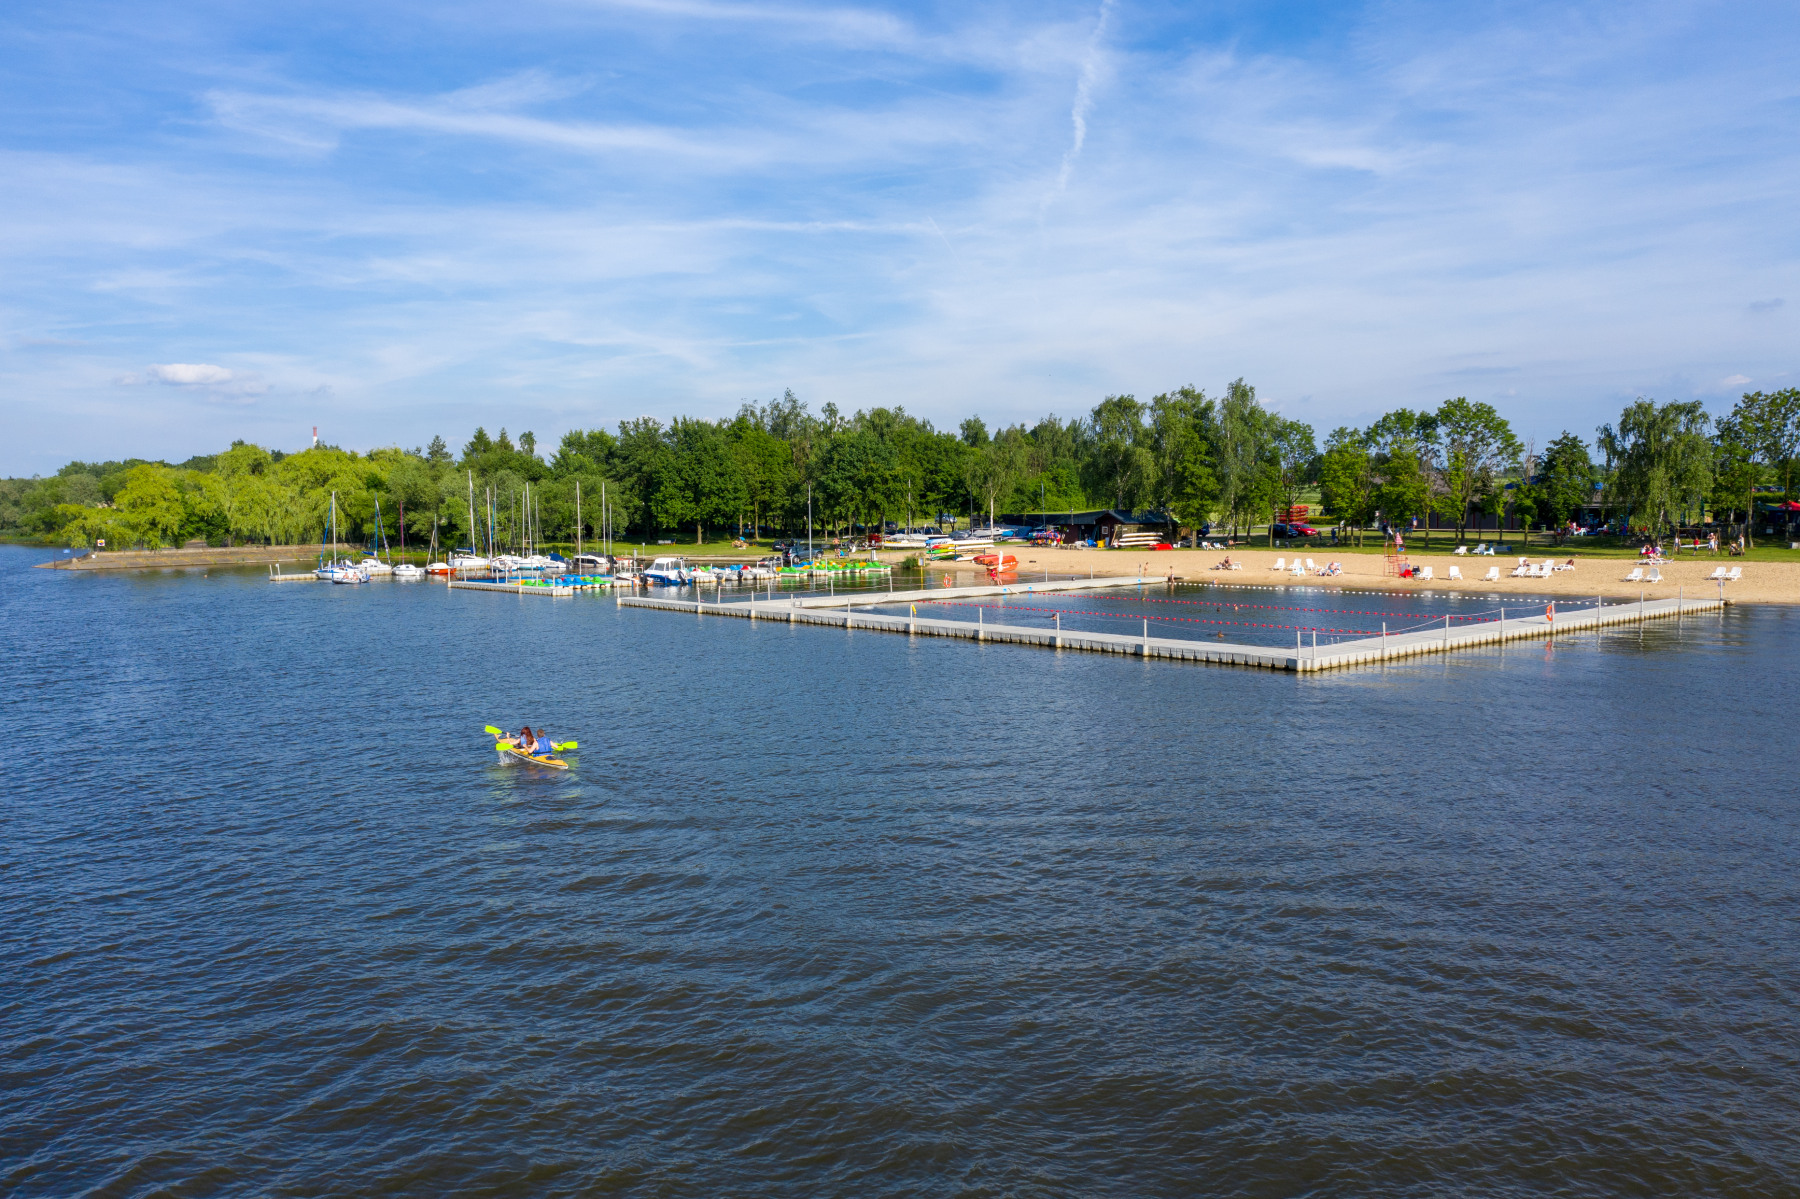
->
[617,578,1724,673]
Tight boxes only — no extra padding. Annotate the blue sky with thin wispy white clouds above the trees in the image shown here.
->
[0,0,1800,473]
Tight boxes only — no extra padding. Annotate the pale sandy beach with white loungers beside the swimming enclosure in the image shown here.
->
[932,545,1800,603]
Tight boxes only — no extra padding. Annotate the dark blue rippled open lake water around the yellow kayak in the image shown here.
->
[0,547,1800,1195]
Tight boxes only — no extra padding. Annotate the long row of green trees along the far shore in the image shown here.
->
[0,380,1800,547]
